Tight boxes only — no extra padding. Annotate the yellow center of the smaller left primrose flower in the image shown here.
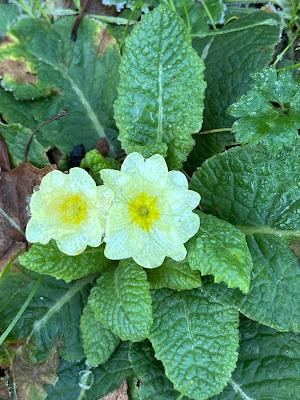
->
[59,194,87,225]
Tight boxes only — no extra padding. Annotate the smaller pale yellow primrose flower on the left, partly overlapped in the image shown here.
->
[26,168,113,256]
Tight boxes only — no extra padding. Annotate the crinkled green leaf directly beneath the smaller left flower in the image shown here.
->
[19,240,113,282]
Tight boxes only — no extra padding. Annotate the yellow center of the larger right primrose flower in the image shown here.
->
[129,192,160,231]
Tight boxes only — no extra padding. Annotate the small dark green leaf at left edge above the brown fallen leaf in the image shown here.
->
[0,123,49,168]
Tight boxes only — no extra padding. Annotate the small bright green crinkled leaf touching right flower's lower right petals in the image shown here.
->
[187,213,253,293]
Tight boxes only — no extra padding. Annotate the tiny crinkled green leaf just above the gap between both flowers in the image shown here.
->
[80,149,120,185]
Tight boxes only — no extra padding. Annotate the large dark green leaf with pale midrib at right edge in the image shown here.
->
[191,140,300,331]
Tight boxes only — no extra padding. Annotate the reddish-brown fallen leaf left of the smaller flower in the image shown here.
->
[0,163,54,270]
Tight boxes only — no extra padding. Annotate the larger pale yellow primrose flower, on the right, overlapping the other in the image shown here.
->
[101,153,200,268]
